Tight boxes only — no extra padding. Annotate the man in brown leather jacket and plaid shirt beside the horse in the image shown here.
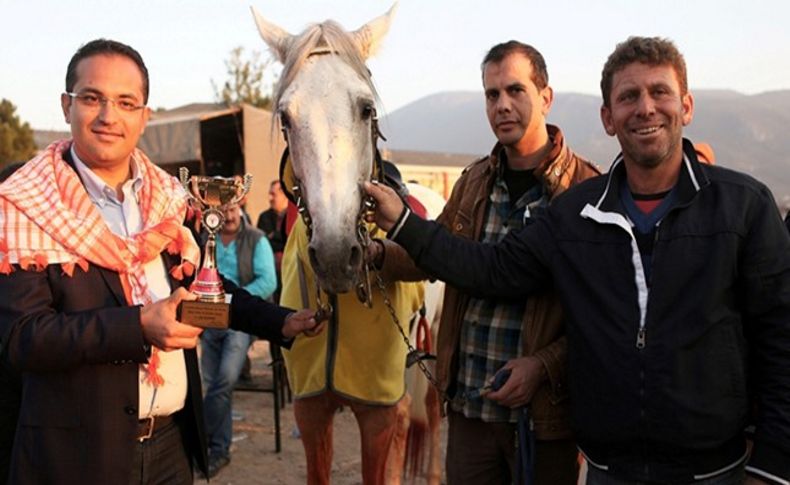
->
[383,41,599,485]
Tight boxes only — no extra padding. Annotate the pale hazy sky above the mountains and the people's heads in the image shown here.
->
[0,0,790,130]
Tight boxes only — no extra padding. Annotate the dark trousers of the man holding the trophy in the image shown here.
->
[129,416,194,485]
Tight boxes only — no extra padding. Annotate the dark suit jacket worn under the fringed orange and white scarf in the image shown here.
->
[0,153,290,485]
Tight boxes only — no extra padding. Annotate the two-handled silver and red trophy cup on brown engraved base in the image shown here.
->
[178,167,252,328]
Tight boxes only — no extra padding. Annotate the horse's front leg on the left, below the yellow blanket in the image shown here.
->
[294,392,339,485]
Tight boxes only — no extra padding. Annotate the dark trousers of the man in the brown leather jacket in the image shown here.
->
[446,411,579,485]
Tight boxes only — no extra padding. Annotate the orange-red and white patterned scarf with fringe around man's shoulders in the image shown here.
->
[0,140,200,385]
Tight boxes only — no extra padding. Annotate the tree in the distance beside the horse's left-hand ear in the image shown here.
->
[211,46,273,109]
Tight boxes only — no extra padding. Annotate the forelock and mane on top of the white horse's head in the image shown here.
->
[272,20,378,110]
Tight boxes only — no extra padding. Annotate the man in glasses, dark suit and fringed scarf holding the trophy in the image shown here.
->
[0,39,316,484]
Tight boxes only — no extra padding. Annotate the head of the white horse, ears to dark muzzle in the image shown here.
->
[252,6,395,293]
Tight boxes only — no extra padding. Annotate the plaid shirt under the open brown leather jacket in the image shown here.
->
[453,158,548,423]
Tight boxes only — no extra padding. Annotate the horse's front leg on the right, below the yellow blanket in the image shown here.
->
[350,399,403,485]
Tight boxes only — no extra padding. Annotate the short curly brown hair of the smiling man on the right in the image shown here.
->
[601,36,688,107]
